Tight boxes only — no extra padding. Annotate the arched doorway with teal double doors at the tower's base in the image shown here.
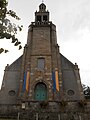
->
[34,82,47,101]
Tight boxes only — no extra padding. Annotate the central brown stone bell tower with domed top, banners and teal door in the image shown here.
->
[19,3,62,101]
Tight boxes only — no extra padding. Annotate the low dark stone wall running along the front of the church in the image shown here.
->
[0,101,90,120]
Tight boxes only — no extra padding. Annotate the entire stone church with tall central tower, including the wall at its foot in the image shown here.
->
[0,3,90,120]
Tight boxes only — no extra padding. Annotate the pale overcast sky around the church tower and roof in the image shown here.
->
[0,0,90,86]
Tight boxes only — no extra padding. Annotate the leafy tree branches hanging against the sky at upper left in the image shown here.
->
[0,0,23,53]
